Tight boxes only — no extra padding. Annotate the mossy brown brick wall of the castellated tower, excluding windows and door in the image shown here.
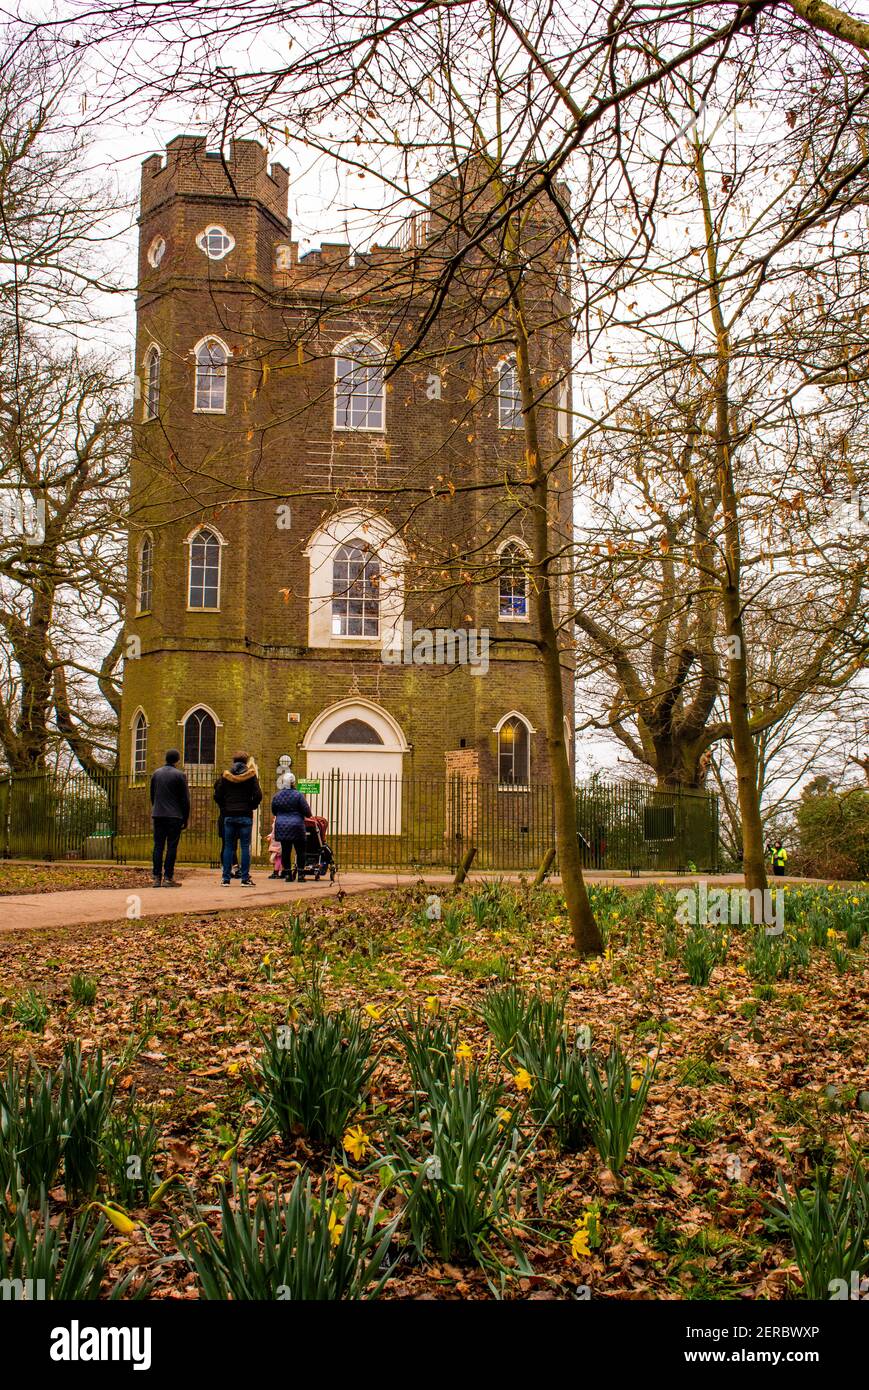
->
[121,138,571,806]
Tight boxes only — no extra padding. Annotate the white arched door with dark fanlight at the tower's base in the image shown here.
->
[302,699,409,835]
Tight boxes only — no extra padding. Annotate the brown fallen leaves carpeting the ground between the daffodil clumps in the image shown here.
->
[0,866,869,1300]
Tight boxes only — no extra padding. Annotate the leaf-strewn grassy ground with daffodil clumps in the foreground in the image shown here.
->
[0,884,869,1300]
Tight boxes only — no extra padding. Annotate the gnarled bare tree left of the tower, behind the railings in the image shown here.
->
[0,336,127,780]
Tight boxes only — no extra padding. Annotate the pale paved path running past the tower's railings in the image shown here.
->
[0,869,808,933]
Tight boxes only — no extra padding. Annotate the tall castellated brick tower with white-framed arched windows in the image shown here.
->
[121,136,571,856]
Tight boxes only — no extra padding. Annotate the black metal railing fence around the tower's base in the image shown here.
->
[0,771,719,872]
